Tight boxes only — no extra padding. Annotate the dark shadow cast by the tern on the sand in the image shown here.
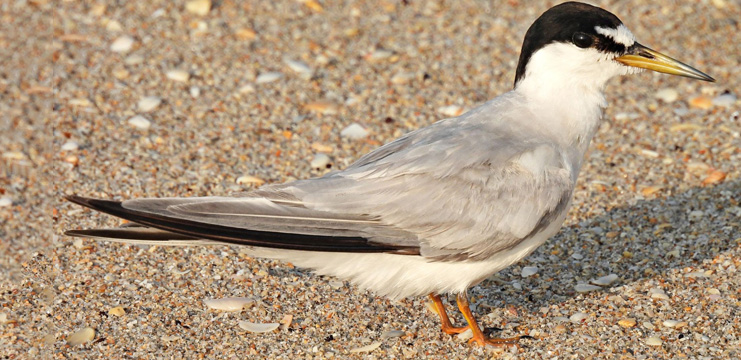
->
[471,180,741,314]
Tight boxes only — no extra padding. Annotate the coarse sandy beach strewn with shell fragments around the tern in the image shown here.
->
[0,0,741,359]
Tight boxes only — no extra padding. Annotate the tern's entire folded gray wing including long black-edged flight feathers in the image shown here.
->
[66,93,573,260]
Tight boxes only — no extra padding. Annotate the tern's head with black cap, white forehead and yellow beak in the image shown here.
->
[515,2,715,89]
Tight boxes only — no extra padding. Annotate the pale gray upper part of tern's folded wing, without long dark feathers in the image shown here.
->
[281,121,574,260]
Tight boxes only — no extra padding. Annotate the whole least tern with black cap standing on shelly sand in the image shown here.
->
[66,2,715,345]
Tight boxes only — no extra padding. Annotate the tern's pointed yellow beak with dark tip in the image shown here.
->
[615,43,715,82]
